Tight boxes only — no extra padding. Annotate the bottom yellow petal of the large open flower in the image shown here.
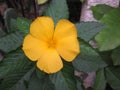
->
[37,48,63,73]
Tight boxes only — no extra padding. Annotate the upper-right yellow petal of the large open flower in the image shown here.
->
[54,19,77,40]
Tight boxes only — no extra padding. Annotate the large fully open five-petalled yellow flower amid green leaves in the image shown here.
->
[23,16,80,73]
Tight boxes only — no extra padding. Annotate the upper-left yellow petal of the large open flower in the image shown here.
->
[30,16,54,40]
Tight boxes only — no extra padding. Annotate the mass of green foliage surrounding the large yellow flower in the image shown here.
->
[0,0,120,90]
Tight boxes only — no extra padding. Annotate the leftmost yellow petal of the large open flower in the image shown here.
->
[22,34,48,61]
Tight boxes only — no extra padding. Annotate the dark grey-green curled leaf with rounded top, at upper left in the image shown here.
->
[4,8,18,33]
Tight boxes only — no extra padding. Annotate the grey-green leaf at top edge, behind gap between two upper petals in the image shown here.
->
[45,0,69,24]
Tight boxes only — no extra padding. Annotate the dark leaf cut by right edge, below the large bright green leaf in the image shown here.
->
[112,47,120,65]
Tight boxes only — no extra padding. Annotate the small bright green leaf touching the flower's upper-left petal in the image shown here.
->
[17,17,32,34]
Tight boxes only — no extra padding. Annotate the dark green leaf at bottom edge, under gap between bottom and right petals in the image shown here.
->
[50,62,77,90]
